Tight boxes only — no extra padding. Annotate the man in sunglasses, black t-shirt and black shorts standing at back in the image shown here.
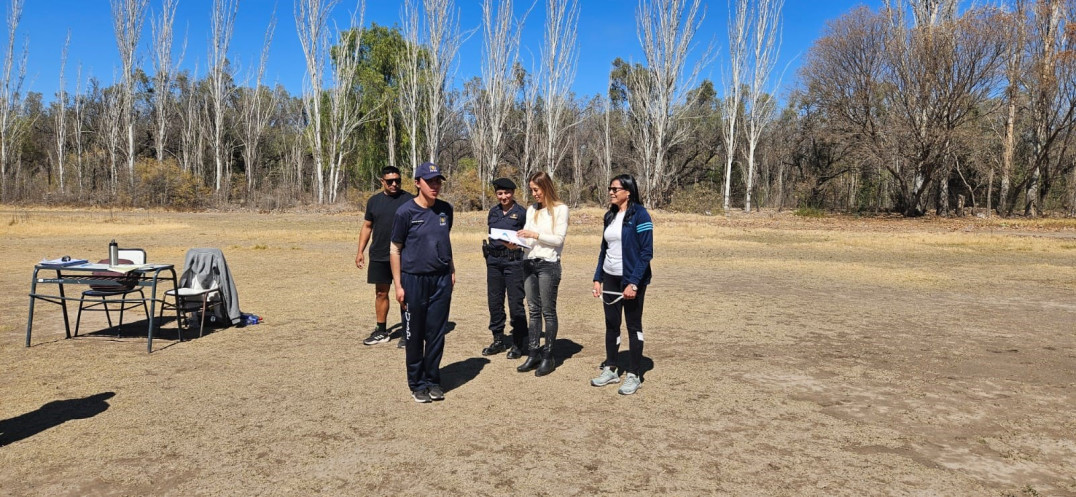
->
[355,166,414,347]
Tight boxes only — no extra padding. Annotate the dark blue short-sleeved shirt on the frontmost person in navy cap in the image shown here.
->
[392,199,452,274]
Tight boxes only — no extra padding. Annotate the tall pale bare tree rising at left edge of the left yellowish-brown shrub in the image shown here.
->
[111,0,150,187]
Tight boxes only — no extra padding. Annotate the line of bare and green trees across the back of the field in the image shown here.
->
[0,0,1076,216]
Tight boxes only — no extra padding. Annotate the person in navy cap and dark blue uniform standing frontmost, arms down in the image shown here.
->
[388,162,456,403]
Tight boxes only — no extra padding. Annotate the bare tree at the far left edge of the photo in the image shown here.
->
[0,0,29,201]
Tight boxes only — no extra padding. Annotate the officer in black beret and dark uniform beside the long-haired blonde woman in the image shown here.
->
[482,178,527,359]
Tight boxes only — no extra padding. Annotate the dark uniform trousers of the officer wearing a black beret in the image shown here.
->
[485,255,527,349]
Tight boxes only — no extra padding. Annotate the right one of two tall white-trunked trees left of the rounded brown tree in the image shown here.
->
[744,0,784,212]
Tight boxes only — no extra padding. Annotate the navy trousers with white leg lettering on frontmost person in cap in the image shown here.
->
[400,272,452,392]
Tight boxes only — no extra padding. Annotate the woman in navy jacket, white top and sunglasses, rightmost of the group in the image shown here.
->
[591,174,654,395]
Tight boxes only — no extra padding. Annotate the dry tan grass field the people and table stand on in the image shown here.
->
[0,207,1076,496]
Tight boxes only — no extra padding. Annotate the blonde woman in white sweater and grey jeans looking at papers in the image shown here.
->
[515,171,568,377]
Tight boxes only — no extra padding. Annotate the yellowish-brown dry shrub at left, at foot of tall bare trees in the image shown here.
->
[132,159,210,211]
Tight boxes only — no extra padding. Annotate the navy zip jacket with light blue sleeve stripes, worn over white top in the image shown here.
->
[594,202,654,287]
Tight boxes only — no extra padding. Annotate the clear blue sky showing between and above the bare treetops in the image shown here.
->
[10,0,880,101]
